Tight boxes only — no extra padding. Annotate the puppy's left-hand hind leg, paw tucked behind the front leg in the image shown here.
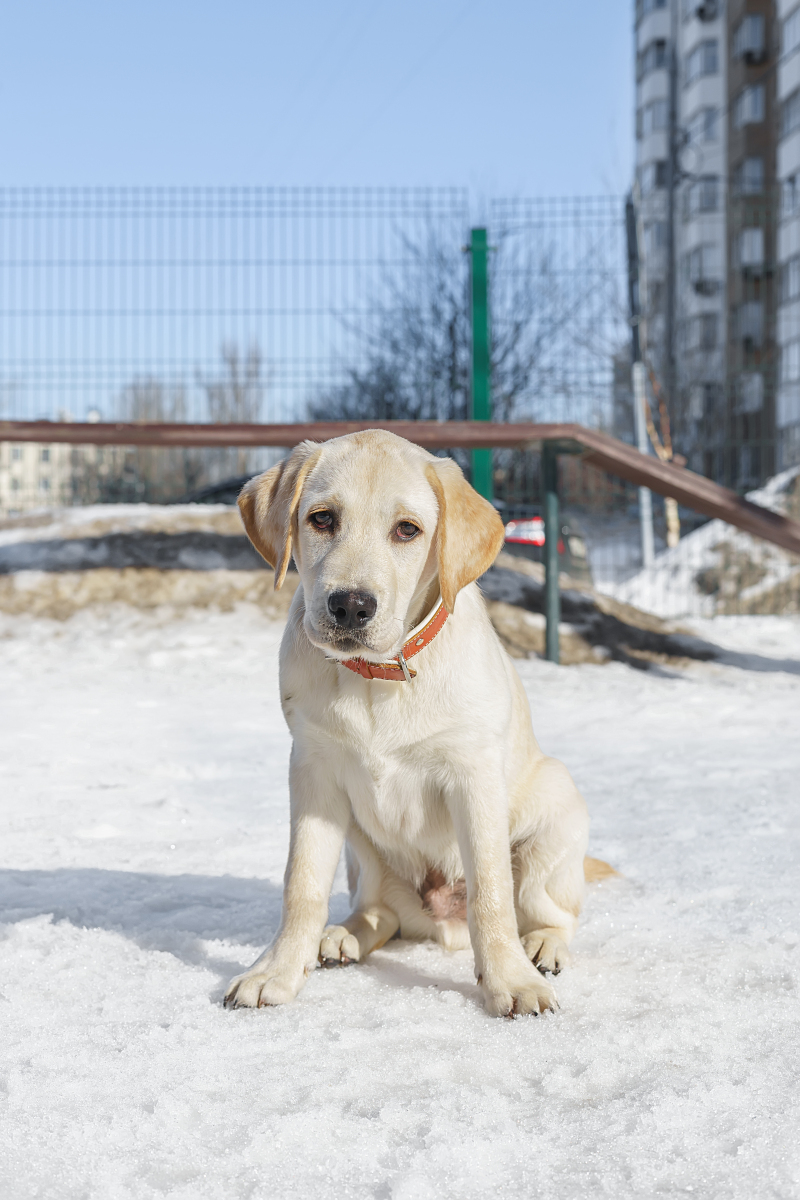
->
[319,824,399,967]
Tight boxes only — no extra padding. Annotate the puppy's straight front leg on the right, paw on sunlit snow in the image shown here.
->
[449,761,558,1016]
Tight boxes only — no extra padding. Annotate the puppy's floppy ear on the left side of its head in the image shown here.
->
[239,442,323,592]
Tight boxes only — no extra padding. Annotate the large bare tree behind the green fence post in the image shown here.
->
[308,226,624,421]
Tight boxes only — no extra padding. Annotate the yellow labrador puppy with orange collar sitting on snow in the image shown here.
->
[225,431,589,1016]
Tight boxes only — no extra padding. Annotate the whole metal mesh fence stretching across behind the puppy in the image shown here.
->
[0,188,796,617]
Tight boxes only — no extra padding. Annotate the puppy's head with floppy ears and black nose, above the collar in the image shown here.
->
[239,430,503,661]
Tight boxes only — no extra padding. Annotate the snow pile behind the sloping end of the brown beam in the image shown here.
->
[606,467,800,618]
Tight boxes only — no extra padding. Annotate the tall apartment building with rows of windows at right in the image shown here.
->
[636,0,800,490]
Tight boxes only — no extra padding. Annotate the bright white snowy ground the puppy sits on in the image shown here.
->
[0,607,800,1200]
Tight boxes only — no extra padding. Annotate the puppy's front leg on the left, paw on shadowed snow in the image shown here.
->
[224,746,350,1008]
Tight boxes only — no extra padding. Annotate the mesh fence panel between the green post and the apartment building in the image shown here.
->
[489,197,631,436]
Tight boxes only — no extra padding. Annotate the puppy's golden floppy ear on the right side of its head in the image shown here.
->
[425,458,505,612]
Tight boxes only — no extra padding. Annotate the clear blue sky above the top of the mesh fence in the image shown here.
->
[0,0,633,198]
